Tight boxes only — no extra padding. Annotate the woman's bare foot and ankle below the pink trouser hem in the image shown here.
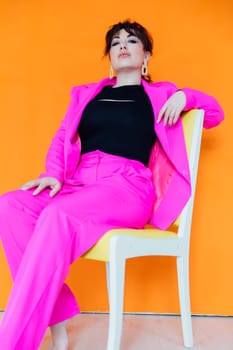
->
[50,321,69,350]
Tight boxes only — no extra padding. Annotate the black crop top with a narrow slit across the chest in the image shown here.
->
[78,85,156,165]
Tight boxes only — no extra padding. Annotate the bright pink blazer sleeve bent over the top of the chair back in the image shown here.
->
[181,88,224,129]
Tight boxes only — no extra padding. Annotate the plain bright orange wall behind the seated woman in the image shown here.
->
[0,0,233,315]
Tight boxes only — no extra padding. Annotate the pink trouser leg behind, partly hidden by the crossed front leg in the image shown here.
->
[0,190,79,325]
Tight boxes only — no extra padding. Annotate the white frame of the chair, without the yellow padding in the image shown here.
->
[84,110,204,350]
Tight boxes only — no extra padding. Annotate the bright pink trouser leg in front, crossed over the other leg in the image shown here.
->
[0,171,155,350]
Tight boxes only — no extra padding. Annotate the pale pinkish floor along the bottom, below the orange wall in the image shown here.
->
[0,313,233,350]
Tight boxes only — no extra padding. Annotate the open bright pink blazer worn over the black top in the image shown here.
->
[42,78,224,229]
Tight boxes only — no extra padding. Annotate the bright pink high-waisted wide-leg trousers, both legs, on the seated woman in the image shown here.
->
[0,151,157,350]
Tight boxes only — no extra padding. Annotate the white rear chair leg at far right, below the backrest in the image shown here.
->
[177,256,193,348]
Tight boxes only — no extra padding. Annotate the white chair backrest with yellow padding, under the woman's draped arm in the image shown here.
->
[173,109,204,239]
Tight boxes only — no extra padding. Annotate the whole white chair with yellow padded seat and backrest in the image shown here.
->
[83,110,204,350]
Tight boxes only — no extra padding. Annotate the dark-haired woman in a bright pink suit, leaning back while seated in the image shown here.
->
[0,21,223,350]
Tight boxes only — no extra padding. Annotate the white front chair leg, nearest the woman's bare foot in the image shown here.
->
[107,258,125,350]
